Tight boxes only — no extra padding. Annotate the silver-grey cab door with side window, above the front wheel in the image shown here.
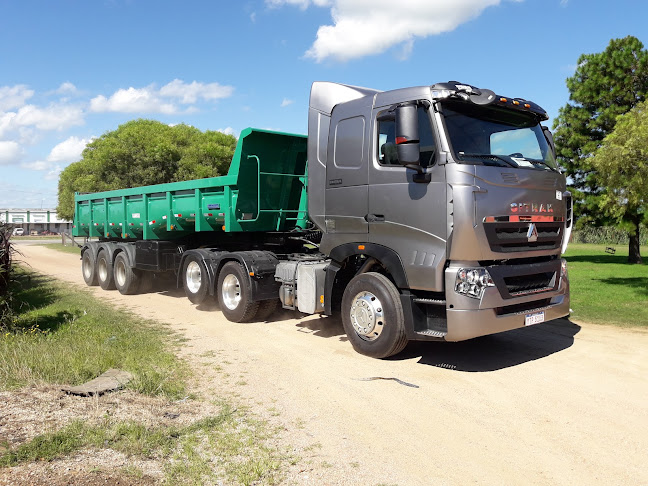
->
[367,103,447,291]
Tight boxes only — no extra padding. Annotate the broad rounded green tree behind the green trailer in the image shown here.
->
[57,120,236,219]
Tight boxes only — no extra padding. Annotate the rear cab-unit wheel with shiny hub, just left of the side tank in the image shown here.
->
[218,262,259,322]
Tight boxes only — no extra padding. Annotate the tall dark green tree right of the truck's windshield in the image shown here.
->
[554,36,648,225]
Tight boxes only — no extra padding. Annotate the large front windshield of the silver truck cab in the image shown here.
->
[442,100,558,170]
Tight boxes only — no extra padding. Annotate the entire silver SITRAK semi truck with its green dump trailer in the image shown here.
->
[73,81,573,358]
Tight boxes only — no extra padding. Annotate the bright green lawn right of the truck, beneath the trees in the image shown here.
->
[565,244,648,328]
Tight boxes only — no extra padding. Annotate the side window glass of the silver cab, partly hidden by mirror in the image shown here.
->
[378,106,436,167]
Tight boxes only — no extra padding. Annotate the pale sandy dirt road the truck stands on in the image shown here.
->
[13,246,648,485]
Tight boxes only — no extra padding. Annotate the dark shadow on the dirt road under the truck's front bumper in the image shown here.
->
[389,319,581,372]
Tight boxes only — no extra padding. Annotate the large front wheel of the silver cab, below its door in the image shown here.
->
[342,272,407,358]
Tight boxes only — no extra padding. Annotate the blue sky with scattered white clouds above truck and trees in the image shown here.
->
[0,0,648,208]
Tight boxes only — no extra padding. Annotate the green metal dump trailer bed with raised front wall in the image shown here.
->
[72,128,308,240]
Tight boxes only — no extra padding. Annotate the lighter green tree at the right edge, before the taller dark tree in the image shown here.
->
[591,102,648,263]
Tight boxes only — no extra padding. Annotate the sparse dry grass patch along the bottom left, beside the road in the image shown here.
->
[0,404,294,485]
